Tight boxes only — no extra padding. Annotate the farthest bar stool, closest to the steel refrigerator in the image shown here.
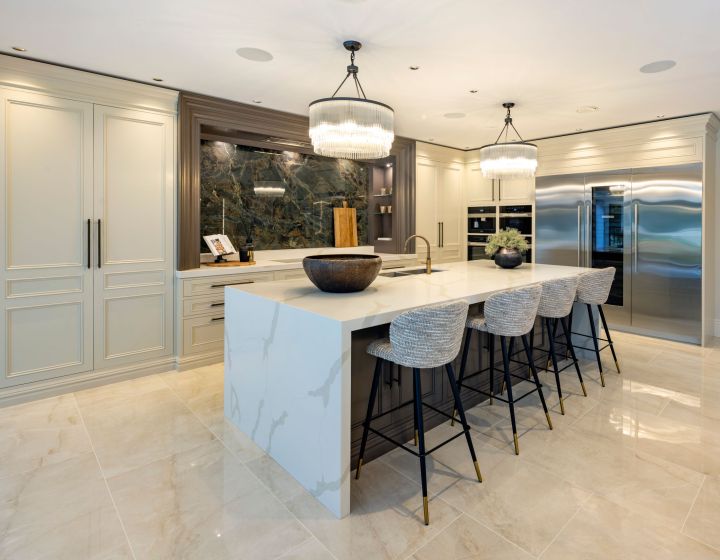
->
[570,266,620,387]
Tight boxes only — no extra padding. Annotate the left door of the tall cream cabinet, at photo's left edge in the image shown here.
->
[0,88,93,387]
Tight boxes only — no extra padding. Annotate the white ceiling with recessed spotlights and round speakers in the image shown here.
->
[0,0,720,148]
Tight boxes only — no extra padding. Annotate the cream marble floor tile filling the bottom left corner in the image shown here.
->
[0,453,133,560]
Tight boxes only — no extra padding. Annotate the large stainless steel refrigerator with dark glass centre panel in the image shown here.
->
[535,163,702,343]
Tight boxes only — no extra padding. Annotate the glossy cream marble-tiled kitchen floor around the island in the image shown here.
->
[0,333,720,560]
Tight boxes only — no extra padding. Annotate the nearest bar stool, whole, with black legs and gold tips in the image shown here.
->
[355,301,482,525]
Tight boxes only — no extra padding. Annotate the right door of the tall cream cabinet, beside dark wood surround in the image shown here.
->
[95,106,175,369]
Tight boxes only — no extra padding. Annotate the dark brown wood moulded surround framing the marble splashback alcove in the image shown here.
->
[177,92,415,270]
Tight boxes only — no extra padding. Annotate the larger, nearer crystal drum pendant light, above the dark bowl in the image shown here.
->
[310,41,395,159]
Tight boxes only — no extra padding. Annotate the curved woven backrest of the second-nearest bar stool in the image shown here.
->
[484,284,542,336]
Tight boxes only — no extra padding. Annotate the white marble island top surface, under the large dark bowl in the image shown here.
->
[226,260,583,330]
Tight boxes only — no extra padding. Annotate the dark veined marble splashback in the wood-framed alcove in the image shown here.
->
[200,140,369,251]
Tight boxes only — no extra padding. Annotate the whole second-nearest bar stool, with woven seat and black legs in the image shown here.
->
[453,284,553,455]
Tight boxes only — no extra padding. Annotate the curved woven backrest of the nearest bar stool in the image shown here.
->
[390,301,468,369]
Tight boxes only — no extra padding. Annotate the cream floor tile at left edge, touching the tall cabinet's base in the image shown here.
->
[0,395,92,478]
